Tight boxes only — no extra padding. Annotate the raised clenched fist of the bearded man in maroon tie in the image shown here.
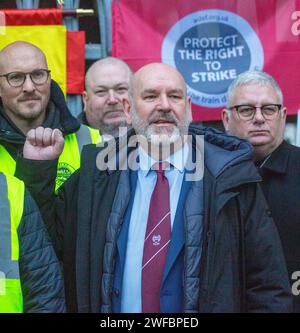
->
[23,127,65,160]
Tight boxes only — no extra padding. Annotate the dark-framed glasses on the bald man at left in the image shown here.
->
[0,69,51,88]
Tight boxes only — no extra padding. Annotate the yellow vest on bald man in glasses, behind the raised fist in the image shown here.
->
[0,125,101,191]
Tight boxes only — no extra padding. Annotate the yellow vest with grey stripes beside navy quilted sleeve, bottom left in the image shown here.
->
[0,173,24,313]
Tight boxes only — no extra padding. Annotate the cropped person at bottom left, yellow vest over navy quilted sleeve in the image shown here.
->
[0,173,65,313]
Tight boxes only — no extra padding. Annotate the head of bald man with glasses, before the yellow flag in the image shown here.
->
[0,41,51,133]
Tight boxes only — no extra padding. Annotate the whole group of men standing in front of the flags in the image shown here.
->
[0,42,300,313]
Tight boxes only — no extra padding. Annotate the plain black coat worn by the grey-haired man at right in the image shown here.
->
[260,141,300,312]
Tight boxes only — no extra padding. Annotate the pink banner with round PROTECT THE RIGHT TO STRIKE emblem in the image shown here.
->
[112,0,300,121]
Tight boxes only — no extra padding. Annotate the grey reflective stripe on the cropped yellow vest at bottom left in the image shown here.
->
[0,173,20,279]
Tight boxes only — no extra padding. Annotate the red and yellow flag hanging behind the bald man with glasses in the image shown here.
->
[0,8,85,94]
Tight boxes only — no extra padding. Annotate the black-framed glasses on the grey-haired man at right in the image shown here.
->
[228,104,282,120]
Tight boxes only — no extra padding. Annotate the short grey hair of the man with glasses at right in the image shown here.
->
[227,71,283,107]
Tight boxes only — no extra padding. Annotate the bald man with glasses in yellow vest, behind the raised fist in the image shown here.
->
[0,41,101,189]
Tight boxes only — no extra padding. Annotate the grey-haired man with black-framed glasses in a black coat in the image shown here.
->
[222,71,300,312]
